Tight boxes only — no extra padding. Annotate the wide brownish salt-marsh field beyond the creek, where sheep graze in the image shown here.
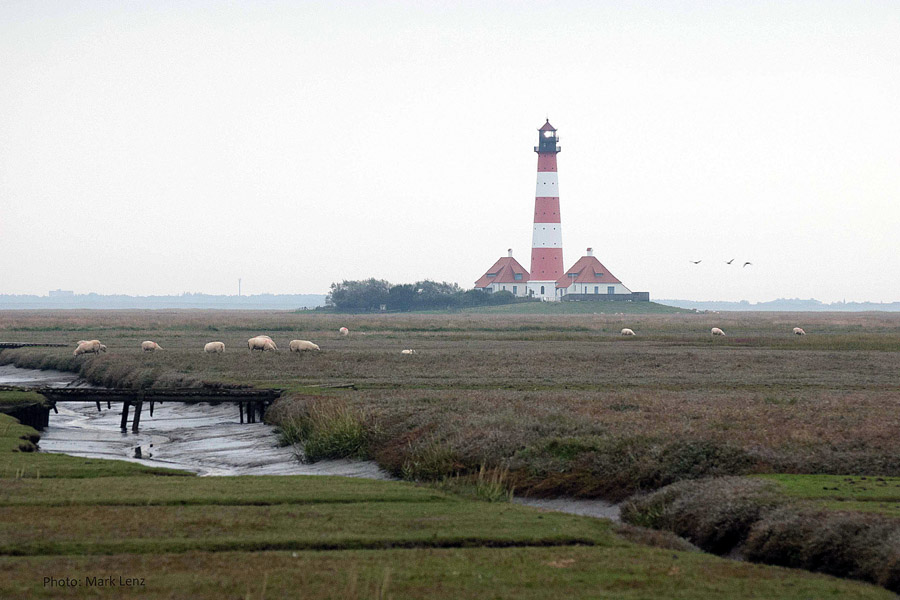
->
[0,310,900,596]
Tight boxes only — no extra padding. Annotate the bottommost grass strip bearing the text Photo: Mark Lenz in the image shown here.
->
[0,546,894,600]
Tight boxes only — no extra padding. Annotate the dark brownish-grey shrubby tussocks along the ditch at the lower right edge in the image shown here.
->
[622,477,900,592]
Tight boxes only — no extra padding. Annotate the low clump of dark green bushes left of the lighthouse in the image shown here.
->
[325,278,525,312]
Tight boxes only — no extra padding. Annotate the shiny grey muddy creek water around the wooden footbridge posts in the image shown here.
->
[0,366,389,479]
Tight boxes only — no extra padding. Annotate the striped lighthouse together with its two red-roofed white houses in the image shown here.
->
[475,119,650,301]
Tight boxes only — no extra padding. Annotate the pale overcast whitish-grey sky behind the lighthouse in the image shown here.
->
[0,0,900,302]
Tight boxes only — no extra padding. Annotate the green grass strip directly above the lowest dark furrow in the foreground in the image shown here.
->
[0,501,625,555]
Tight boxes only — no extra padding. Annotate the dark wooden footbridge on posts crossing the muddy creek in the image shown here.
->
[0,386,282,433]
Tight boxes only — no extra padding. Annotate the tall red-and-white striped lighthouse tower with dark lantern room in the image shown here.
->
[528,119,565,300]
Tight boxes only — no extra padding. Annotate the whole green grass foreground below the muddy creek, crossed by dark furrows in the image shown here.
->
[0,416,891,599]
